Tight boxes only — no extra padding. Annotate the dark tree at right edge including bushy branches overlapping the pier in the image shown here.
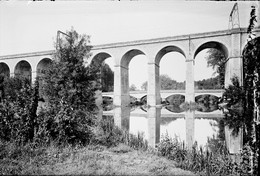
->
[219,7,260,175]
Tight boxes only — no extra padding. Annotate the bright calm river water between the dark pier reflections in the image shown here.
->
[103,107,220,146]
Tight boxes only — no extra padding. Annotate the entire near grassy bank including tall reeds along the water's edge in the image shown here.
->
[0,118,250,175]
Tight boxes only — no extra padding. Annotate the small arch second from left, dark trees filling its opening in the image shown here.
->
[14,60,32,80]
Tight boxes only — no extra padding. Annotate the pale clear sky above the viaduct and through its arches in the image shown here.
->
[0,0,253,88]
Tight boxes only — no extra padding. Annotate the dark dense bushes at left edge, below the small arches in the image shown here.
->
[0,78,39,144]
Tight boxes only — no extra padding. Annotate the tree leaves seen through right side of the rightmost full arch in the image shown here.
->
[206,48,227,88]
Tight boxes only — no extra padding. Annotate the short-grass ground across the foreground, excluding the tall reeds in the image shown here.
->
[0,144,194,175]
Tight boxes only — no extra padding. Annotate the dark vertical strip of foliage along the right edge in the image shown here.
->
[243,37,260,173]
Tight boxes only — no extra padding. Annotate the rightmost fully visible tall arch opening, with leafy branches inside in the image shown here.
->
[194,41,228,89]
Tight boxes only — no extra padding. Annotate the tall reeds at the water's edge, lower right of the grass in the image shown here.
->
[154,135,246,175]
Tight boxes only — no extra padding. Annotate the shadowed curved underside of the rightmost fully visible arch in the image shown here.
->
[193,41,229,59]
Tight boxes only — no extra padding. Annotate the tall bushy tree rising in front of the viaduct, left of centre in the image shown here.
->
[39,28,100,143]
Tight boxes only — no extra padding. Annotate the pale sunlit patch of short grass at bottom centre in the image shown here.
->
[42,145,194,175]
